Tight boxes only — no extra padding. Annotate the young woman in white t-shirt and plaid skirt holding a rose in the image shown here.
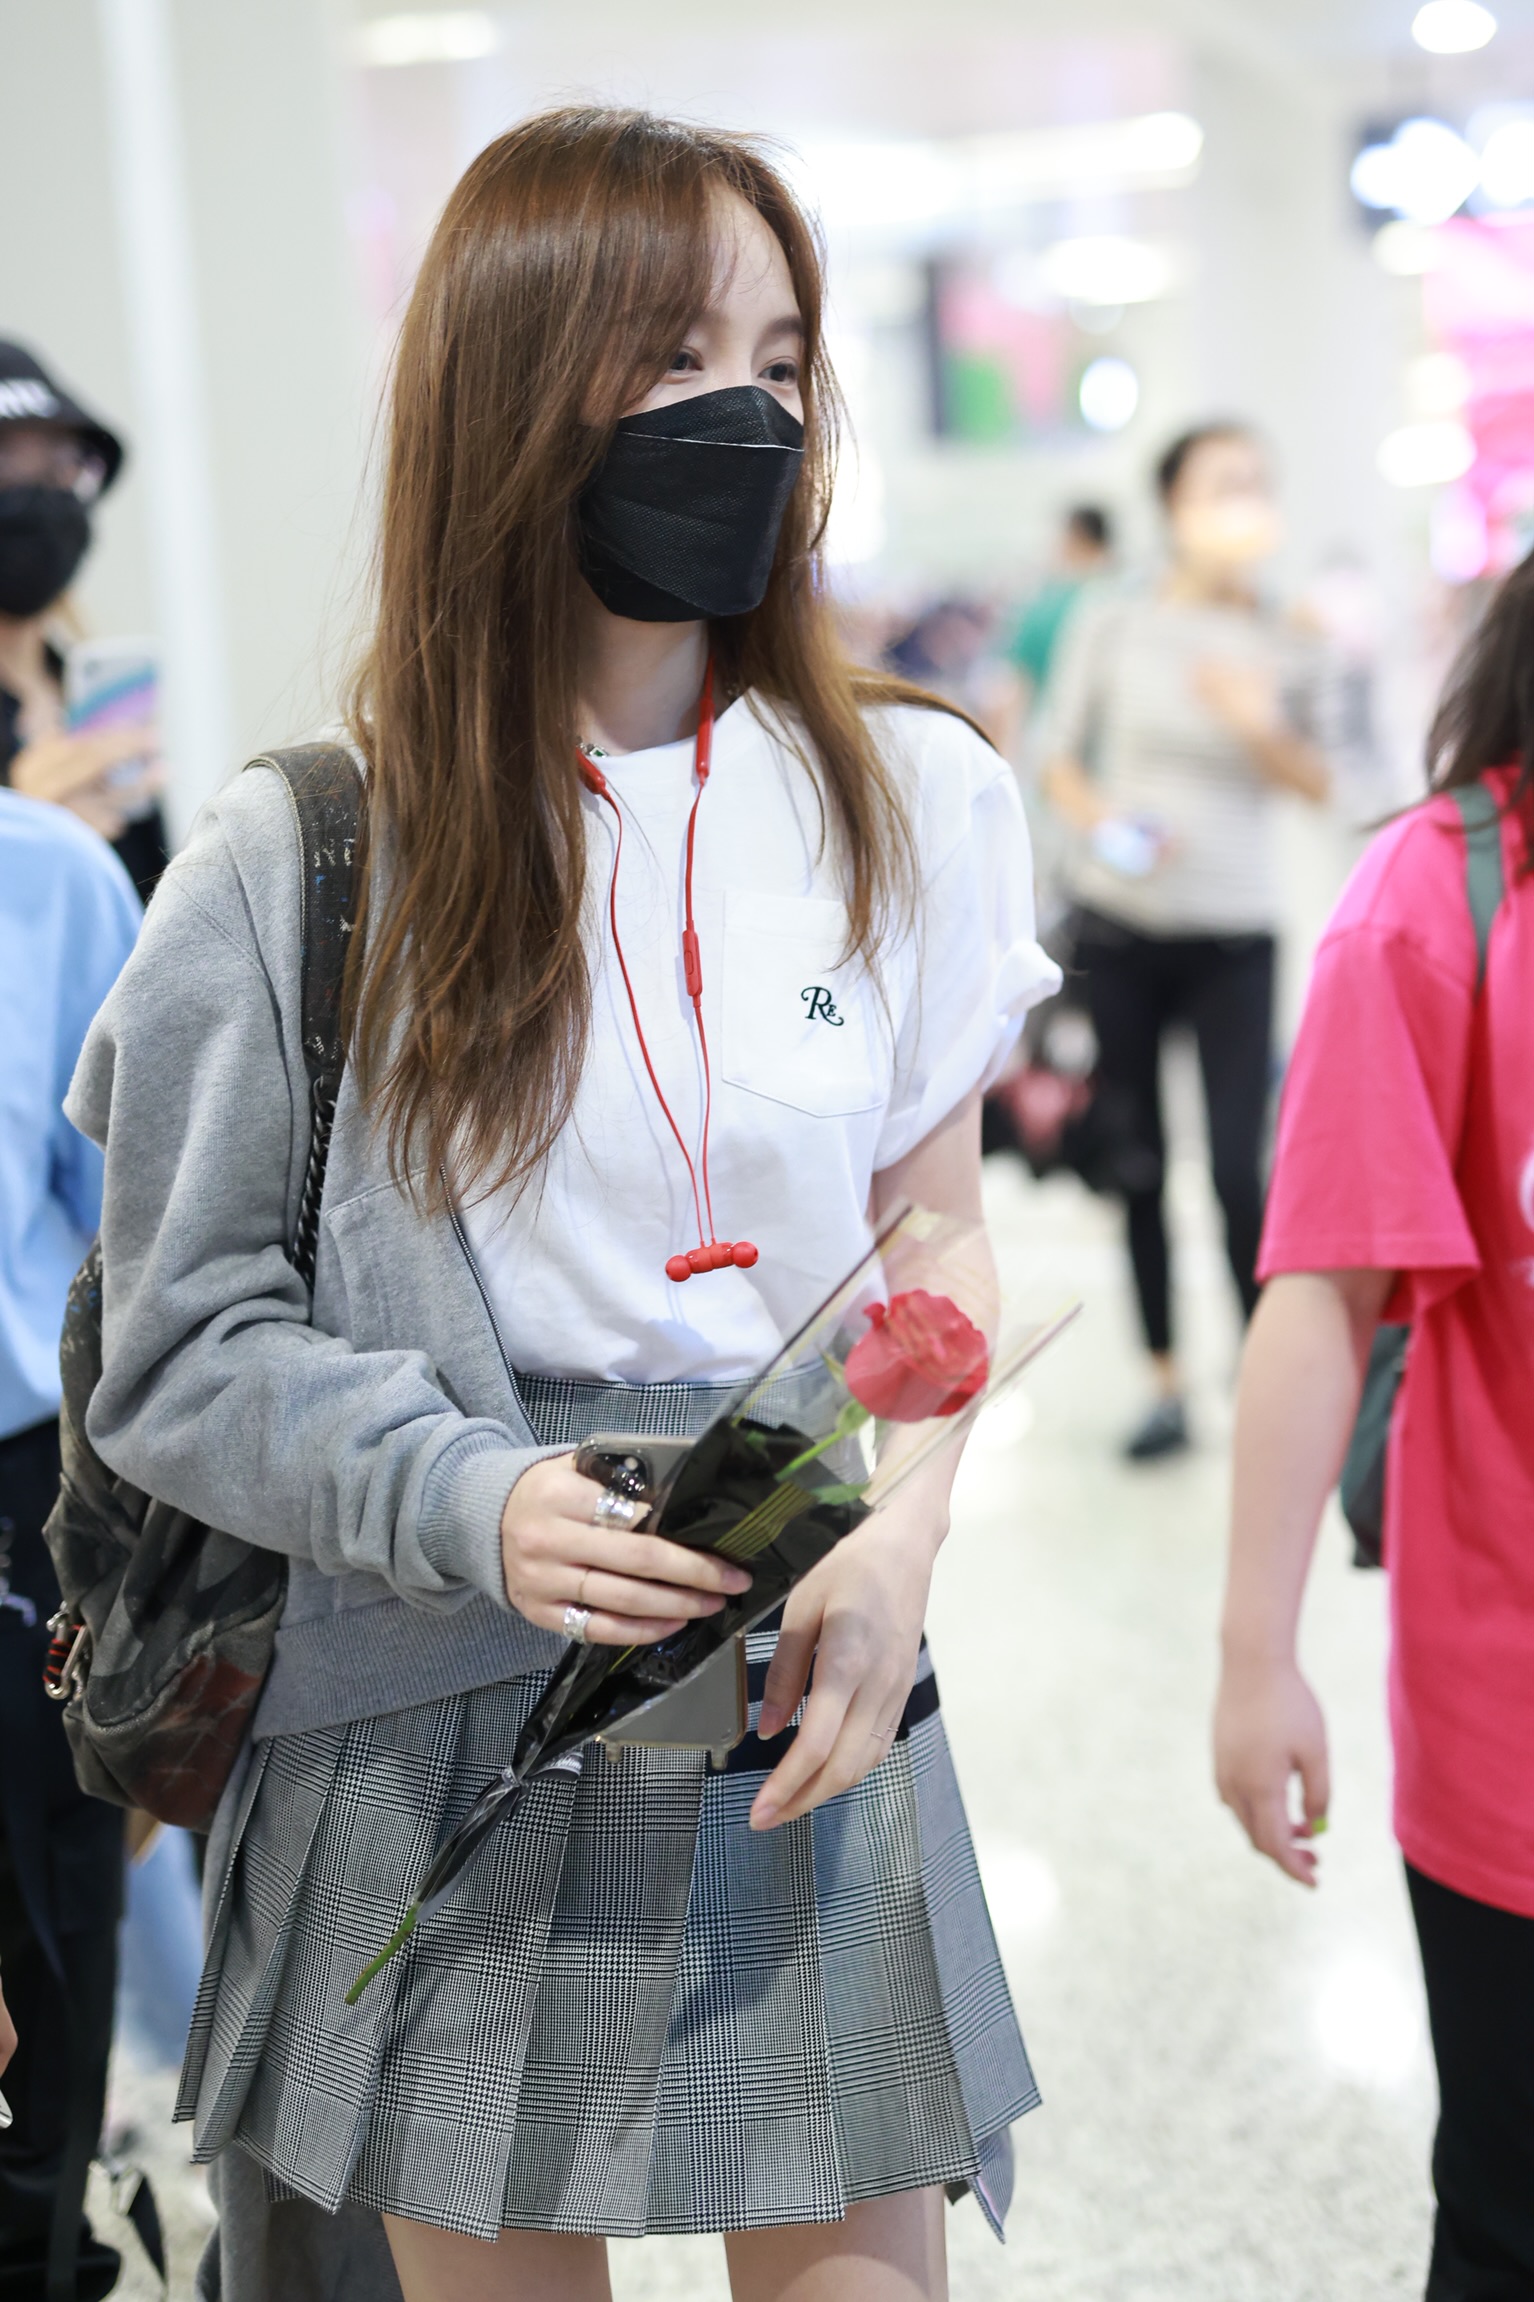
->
[71,110,1055,2302]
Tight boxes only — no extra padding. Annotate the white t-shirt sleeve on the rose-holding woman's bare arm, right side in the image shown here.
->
[873,711,1060,1172]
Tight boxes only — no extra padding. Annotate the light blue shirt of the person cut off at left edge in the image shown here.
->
[0,787,143,1439]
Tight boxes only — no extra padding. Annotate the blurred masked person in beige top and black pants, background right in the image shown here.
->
[1039,424,1329,1462]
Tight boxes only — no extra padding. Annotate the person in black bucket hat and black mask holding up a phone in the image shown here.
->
[0,343,166,900]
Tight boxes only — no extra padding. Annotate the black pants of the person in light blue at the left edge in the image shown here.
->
[0,1423,122,2302]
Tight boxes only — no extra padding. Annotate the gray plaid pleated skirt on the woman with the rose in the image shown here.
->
[177,1379,1039,2238]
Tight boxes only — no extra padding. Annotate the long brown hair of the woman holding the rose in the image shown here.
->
[348,108,926,1206]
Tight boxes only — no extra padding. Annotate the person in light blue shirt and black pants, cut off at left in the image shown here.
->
[0,782,141,2302]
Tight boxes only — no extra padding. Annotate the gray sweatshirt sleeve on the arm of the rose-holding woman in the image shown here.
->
[69,773,550,1607]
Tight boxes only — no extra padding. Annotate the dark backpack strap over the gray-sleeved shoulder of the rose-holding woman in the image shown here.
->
[249,744,362,1287]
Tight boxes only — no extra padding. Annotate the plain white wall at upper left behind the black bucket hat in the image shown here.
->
[0,0,371,829]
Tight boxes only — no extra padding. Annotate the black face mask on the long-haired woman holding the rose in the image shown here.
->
[578,384,804,624]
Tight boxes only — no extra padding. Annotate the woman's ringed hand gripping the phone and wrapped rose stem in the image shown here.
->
[500,1455,751,1646]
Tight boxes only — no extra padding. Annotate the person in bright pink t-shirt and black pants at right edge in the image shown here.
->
[1214,555,1534,2302]
